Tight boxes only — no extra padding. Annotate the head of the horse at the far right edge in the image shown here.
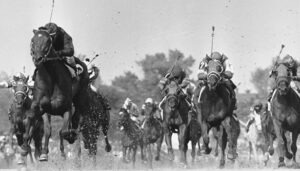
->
[273,63,291,95]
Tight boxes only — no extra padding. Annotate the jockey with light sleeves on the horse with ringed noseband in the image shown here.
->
[198,52,237,109]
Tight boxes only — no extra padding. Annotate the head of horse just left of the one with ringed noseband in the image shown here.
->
[166,81,180,111]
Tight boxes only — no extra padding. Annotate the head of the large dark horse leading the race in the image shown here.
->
[30,30,53,66]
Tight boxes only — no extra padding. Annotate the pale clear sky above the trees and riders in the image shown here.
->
[0,0,300,91]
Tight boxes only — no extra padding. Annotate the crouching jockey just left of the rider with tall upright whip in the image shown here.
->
[158,65,191,110]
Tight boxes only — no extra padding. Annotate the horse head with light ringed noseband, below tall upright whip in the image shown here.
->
[207,60,224,90]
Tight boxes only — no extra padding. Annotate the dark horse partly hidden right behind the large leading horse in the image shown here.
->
[81,87,111,166]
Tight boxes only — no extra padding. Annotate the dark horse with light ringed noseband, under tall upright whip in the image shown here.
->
[193,60,235,167]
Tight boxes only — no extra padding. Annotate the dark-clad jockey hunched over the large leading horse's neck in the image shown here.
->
[34,23,81,79]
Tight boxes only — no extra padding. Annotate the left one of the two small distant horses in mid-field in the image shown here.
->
[119,108,144,167]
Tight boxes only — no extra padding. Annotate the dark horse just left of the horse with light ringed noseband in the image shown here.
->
[161,81,200,166]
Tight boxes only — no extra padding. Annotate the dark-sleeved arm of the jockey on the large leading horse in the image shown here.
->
[57,28,74,56]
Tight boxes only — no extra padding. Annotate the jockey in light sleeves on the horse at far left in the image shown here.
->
[0,72,27,120]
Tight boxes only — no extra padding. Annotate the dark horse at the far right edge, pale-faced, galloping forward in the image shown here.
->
[271,63,300,167]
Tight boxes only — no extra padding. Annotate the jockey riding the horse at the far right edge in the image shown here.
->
[268,55,300,102]
